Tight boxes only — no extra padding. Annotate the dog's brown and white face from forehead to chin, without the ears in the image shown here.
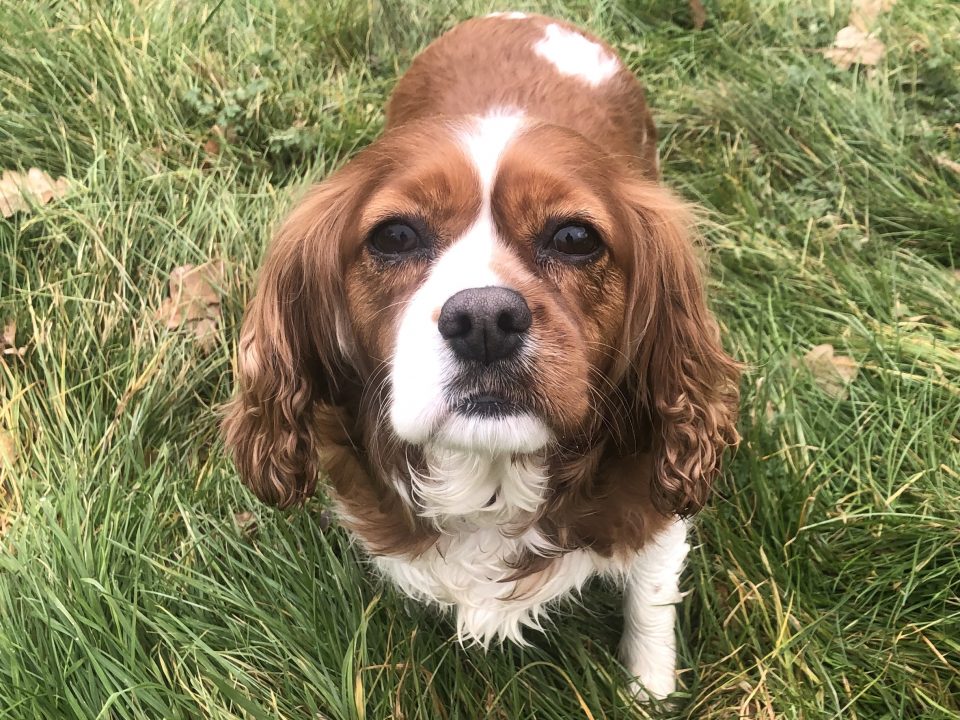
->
[360,116,635,453]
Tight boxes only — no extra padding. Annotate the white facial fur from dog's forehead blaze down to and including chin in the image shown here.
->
[390,110,550,453]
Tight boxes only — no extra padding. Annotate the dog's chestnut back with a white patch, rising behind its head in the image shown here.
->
[387,13,658,179]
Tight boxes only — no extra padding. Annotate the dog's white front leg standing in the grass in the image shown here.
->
[620,520,690,700]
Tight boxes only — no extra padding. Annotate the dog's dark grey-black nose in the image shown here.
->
[437,287,533,365]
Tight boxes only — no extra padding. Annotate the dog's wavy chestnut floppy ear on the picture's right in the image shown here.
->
[625,181,740,516]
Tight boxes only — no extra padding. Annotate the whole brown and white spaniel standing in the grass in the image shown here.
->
[226,13,739,697]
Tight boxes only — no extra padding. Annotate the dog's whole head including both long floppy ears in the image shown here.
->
[227,112,737,514]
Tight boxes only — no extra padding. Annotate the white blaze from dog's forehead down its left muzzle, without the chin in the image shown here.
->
[390,110,530,450]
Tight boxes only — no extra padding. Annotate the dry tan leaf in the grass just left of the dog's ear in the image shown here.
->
[157,260,225,352]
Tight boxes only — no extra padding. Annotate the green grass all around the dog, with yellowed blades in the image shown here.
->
[0,0,960,720]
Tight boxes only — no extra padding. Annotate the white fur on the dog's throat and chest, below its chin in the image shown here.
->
[374,446,610,647]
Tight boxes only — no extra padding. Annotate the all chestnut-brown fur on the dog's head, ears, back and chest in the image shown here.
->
[225,12,739,578]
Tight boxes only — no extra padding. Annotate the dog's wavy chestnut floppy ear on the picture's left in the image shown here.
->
[224,166,370,507]
